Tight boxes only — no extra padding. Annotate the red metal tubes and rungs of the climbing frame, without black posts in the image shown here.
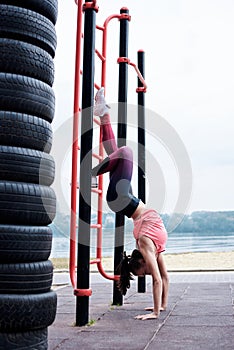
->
[69,0,147,290]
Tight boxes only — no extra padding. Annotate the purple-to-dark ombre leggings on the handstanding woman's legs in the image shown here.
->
[92,114,140,218]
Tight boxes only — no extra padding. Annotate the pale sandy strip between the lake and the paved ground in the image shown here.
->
[51,251,234,272]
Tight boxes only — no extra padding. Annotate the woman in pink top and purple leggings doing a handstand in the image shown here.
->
[92,88,169,320]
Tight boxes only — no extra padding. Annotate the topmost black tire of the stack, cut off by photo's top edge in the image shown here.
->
[0,0,58,24]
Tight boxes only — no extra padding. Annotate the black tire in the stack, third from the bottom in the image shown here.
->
[0,260,53,294]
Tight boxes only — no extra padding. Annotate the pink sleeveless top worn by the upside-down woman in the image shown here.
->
[133,209,167,253]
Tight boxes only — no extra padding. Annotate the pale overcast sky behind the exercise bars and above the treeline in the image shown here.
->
[53,0,234,216]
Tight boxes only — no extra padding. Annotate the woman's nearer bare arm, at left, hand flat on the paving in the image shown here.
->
[136,236,162,320]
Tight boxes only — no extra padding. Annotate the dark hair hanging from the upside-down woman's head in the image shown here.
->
[117,249,144,295]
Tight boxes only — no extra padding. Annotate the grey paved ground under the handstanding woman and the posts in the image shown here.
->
[49,273,234,350]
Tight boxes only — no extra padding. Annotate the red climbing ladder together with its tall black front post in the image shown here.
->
[69,0,146,326]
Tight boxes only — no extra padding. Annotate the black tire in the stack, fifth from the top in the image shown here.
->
[0,111,53,153]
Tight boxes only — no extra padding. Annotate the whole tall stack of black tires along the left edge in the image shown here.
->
[0,0,58,350]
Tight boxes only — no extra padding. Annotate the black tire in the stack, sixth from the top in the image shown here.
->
[0,146,55,186]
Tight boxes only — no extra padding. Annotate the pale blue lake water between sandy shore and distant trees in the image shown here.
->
[51,230,234,258]
